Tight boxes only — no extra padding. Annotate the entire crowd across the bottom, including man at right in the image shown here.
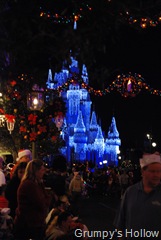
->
[0,149,161,240]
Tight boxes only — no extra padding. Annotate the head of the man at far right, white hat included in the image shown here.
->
[140,152,161,188]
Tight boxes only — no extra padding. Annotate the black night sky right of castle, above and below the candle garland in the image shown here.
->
[92,26,161,150]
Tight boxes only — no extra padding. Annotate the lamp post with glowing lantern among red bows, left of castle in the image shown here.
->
[27,84,44,159]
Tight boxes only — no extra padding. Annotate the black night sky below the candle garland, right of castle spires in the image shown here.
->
[94,93,161,149]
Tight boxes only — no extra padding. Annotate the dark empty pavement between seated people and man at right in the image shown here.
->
[80,195,120,239]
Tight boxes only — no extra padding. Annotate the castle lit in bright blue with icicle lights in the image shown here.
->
[46,54,121,167]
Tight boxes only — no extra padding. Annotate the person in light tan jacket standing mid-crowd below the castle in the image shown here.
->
[69,172,84,215]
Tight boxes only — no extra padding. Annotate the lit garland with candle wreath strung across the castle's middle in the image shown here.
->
[6,72,161,98]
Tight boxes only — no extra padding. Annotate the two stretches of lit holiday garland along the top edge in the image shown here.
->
[40,0,161,29]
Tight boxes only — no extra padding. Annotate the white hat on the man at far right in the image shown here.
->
[140,153,161,168]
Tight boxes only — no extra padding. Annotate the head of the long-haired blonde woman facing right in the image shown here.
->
[22,159,46,182]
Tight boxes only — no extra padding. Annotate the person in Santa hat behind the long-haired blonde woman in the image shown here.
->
[10,149,32,178]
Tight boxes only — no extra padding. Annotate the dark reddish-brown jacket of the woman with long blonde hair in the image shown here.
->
[15,180,51,229]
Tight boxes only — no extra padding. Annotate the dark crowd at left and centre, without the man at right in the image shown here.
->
[0,149,148,240]
